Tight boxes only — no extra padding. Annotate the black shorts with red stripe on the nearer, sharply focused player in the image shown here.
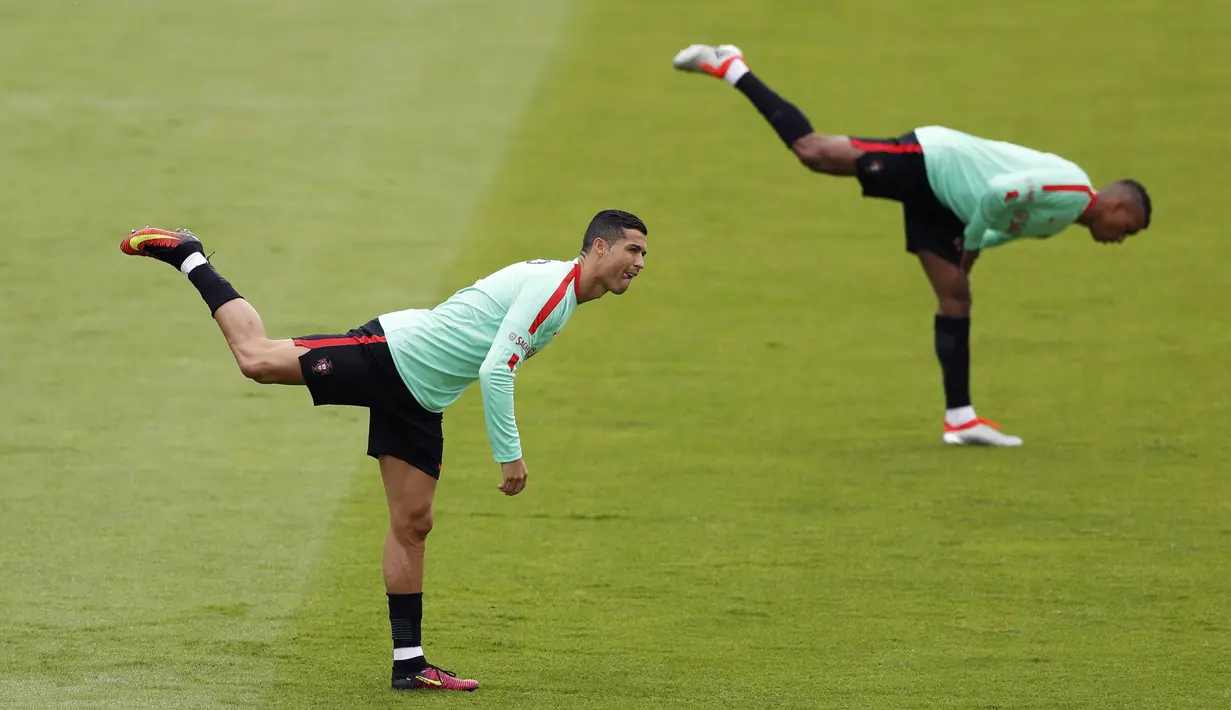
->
[294,320,444,479]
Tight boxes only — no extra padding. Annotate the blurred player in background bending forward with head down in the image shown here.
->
[673,44,1151,447]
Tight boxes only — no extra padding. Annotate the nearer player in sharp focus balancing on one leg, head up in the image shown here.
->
[119,209,646,690]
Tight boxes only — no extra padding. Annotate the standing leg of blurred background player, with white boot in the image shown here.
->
[918,251,1022,447]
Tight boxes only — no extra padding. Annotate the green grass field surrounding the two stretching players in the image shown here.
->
[0,0,1231,709]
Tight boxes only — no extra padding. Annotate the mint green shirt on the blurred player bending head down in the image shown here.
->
[915,126,1094,251]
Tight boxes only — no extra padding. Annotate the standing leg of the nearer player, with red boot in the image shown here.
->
[378,455,479,690]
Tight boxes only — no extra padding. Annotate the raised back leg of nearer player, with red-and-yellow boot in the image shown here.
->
[119,226,308,385]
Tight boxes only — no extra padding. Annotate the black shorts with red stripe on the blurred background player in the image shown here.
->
[851,130,966,263]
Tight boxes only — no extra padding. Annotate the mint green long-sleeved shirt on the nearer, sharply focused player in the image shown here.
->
[380,260,581,463]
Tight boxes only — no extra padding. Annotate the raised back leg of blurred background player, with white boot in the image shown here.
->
[672,44,864,176]
